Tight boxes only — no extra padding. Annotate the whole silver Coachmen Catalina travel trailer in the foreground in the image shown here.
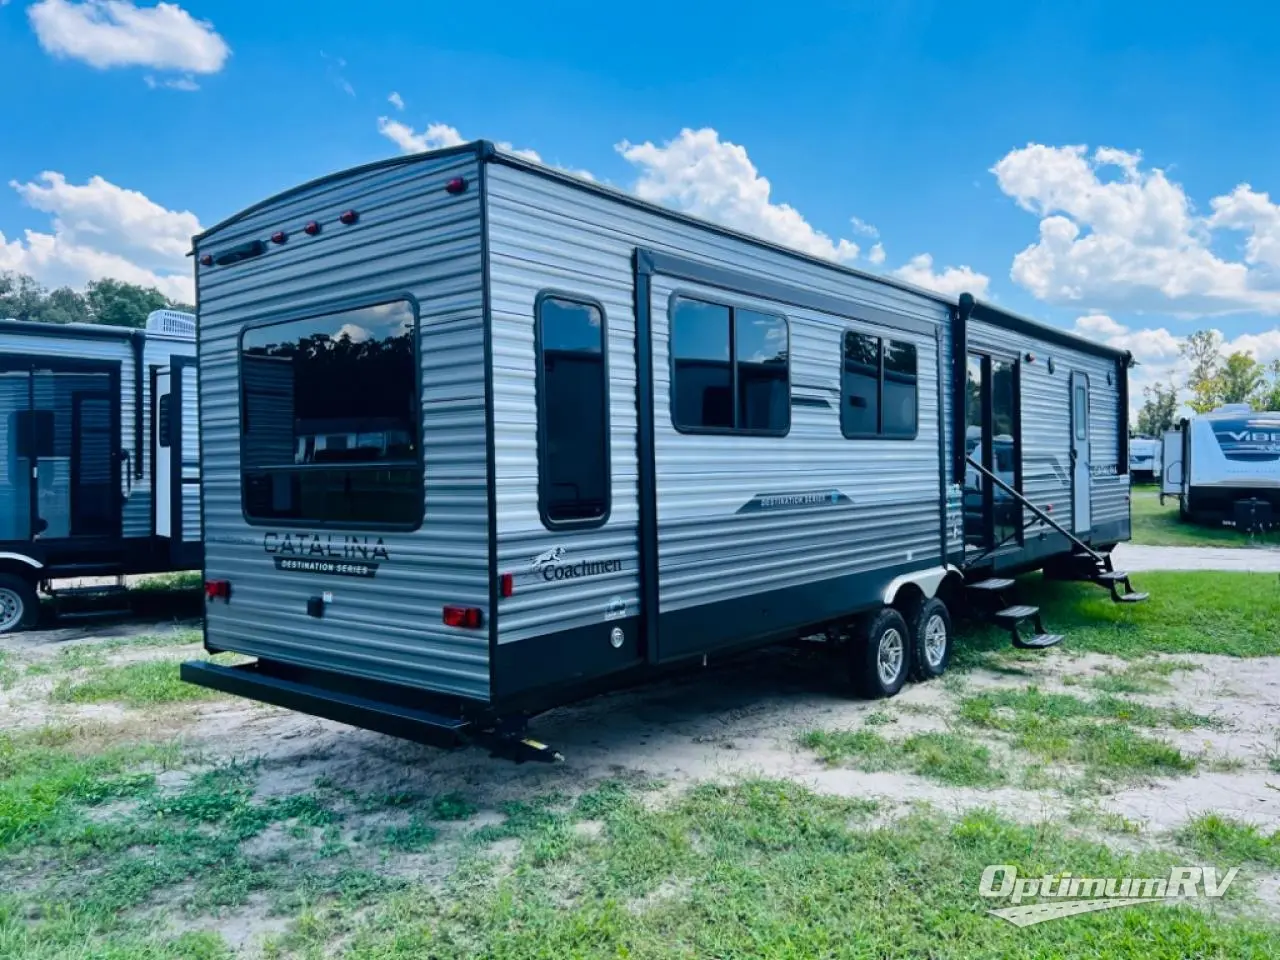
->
[182,142,1142,757]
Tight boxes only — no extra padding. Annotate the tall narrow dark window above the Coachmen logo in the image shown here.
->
[536,294,609,526]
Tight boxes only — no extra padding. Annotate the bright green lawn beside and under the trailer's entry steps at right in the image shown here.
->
[954,571,1280,667]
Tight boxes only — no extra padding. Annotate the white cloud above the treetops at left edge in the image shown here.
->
[0,172,201,303]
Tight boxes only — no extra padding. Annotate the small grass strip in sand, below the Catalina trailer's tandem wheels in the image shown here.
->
[800,730,1006,787]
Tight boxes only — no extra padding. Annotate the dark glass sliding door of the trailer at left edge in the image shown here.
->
[0,357,122,540]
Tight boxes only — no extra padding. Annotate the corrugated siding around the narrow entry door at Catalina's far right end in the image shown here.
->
[968,320,1129,530]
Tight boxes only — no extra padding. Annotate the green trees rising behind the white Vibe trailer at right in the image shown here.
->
[1138,330,1280,436]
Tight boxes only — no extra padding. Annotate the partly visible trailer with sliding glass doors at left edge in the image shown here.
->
[0,310,201,632]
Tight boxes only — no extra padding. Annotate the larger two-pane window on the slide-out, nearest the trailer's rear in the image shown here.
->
[671,297,791,436]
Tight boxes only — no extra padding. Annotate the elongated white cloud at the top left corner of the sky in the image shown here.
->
[27,0,230,73]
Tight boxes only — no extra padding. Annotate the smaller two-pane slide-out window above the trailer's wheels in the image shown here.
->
[840,330,919,440]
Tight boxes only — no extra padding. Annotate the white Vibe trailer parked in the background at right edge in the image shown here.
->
[1160,403,1280,530]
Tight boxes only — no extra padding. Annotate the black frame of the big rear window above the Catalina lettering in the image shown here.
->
[236,291,426,532]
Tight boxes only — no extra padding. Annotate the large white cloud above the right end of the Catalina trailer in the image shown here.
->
[992,143,1280,315]
